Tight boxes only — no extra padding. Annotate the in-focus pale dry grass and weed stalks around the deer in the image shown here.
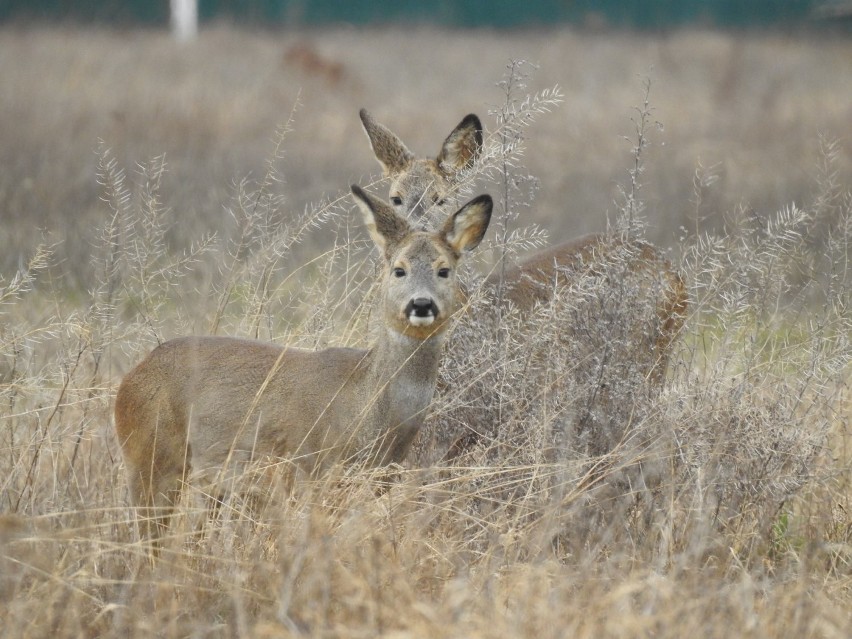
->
[0,72,852,637]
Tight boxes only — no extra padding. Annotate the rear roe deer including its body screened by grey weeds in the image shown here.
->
[360,109,687,465]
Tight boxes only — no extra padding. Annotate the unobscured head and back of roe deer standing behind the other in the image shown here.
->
[360,109,687,386]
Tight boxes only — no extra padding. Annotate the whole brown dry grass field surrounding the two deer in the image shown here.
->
[0,26,852,639]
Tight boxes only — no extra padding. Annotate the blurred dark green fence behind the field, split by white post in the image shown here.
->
[0,0,824,29]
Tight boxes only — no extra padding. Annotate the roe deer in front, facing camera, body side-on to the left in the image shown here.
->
[115,186,492,537]
